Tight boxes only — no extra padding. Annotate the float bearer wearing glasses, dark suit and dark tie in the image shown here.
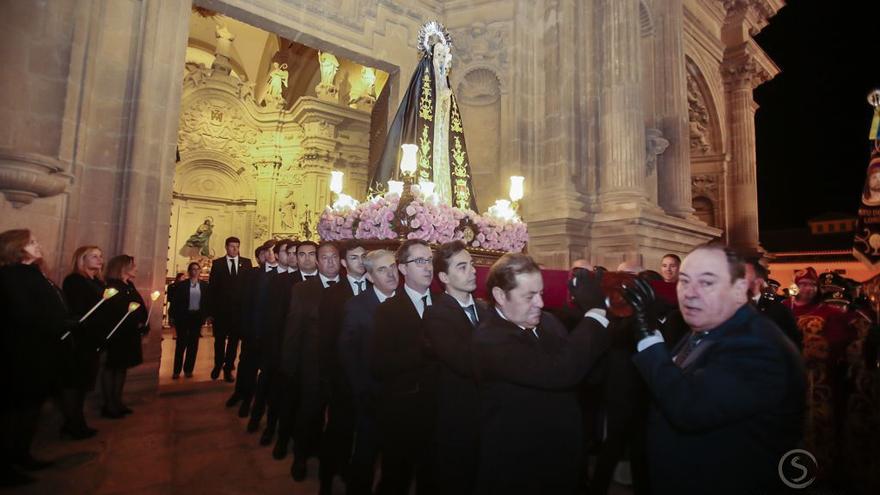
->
[370,239,437,494]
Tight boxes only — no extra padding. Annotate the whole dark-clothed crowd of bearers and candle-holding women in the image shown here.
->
[0,227,824,494]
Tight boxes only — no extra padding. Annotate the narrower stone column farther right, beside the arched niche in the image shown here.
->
[654,0,694,218]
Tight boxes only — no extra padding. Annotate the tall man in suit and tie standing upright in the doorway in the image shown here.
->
[208,237,251,382]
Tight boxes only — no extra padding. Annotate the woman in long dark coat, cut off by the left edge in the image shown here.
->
[0,229,68,487]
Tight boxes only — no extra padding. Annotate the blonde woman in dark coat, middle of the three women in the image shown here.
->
[60,246,106,439]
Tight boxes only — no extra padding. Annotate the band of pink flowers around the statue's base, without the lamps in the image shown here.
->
[318,188,529,252]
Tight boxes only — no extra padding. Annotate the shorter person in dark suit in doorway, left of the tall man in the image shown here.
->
[168,261,210,379]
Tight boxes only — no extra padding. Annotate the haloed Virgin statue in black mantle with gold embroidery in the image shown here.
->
[370,21,477,211]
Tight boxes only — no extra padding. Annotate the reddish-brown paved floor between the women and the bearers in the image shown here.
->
[15,335,629,495]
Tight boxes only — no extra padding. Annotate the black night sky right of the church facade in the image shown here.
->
[755,0,880,231]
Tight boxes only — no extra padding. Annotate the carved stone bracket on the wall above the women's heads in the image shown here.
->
[0,150,72,208]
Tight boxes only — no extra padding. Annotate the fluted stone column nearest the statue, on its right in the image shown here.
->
[599,0,647,211]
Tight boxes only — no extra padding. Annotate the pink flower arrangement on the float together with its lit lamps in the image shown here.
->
[318,151,529,252]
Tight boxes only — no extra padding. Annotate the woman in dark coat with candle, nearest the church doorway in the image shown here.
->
[100,254,147,419]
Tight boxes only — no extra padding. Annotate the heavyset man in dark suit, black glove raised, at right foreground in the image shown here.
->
[628,244,806,495]
